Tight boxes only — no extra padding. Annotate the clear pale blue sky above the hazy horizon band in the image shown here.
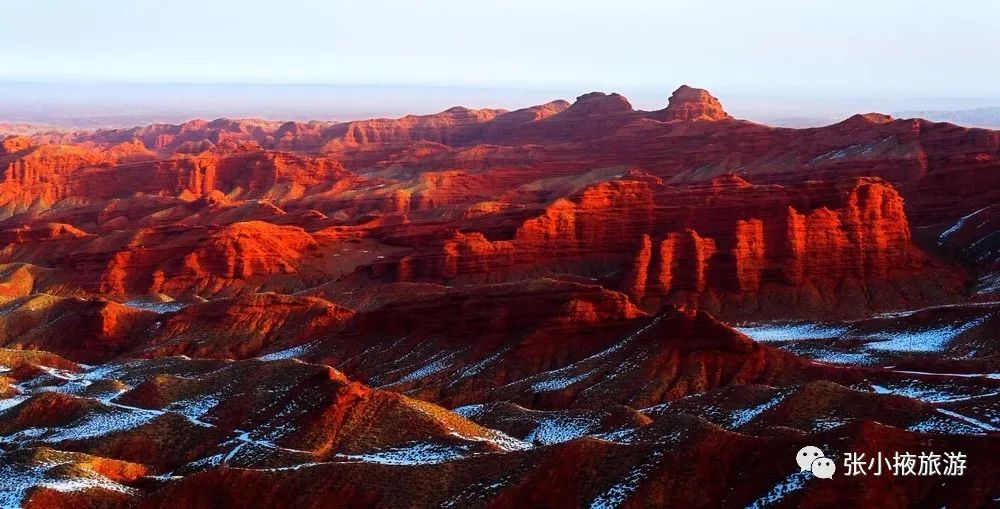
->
[0,0,1000,97]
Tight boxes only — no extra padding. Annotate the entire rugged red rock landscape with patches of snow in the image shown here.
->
[0,86,1000,507]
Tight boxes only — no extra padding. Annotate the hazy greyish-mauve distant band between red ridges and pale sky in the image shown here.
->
[0,78,1000,130]
